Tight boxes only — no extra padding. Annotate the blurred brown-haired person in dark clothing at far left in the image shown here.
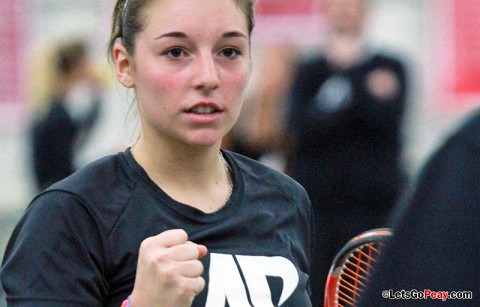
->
[31,40,100,190]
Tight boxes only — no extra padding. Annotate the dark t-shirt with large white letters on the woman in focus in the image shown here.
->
[1,150,313,307]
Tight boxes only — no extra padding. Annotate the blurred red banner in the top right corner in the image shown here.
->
[431,0,480,110]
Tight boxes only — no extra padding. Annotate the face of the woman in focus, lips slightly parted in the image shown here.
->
[121,0,250,146]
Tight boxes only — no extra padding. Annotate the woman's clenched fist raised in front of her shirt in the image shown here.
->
[131,229,207,307]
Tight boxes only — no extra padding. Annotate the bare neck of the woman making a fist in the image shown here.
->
[132,137,231,212]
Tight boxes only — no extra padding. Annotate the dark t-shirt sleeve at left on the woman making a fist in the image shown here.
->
[0,191,107,306]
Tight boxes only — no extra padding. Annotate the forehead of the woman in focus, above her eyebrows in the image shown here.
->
[143,0,248,33]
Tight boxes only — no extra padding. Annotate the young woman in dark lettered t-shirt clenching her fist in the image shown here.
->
[1,0,312,307]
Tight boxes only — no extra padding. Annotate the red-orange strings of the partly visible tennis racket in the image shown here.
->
[337,242,384,306]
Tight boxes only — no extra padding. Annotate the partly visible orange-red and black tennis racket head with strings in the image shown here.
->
[324,228,392,307]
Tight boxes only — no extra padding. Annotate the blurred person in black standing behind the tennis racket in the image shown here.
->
[286,0,407,306]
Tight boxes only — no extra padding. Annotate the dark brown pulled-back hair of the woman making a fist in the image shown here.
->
[108,0,256,62]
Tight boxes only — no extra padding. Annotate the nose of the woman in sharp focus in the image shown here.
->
[193,54,220,93]
